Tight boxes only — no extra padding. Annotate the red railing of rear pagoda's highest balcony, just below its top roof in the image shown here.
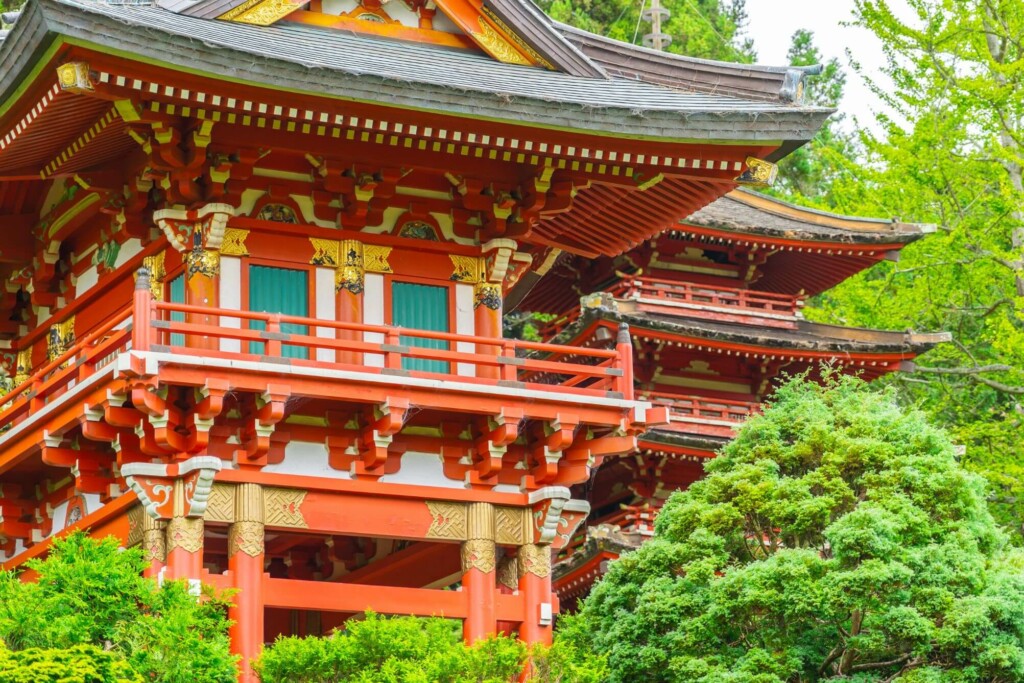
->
[614,278,803,317]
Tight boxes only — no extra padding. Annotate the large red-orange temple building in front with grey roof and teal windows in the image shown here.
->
[0,0,829,681]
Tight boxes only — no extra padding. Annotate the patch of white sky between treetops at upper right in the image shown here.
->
[746,0,908,128]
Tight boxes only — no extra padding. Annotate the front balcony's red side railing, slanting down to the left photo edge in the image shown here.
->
[0,309,132,432]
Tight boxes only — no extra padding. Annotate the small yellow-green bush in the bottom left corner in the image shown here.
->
[0,645,142,683]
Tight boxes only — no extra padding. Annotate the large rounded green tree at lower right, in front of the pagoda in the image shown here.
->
[563,371,1024,683]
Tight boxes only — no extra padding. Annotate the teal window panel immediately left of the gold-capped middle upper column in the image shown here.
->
[249,265,309,358]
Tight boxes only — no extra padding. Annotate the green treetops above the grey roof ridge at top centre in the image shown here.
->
[538,0,755,62]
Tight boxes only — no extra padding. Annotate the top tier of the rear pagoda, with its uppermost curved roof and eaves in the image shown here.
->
[520,188,935,312]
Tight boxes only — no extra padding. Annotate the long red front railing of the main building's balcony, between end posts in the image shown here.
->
[133,280,633,399]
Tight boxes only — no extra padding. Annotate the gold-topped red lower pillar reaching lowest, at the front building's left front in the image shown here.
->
[227,483,264,683]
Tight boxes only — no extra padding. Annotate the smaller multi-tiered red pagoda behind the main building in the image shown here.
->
[528,189,949,607]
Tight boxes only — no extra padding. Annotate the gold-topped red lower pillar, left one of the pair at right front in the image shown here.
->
[462,503,498,644]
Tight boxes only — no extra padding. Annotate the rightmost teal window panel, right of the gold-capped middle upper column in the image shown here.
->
[391,283,450,373]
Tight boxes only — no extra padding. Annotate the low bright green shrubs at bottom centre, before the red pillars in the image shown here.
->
[255,612,604,683]
